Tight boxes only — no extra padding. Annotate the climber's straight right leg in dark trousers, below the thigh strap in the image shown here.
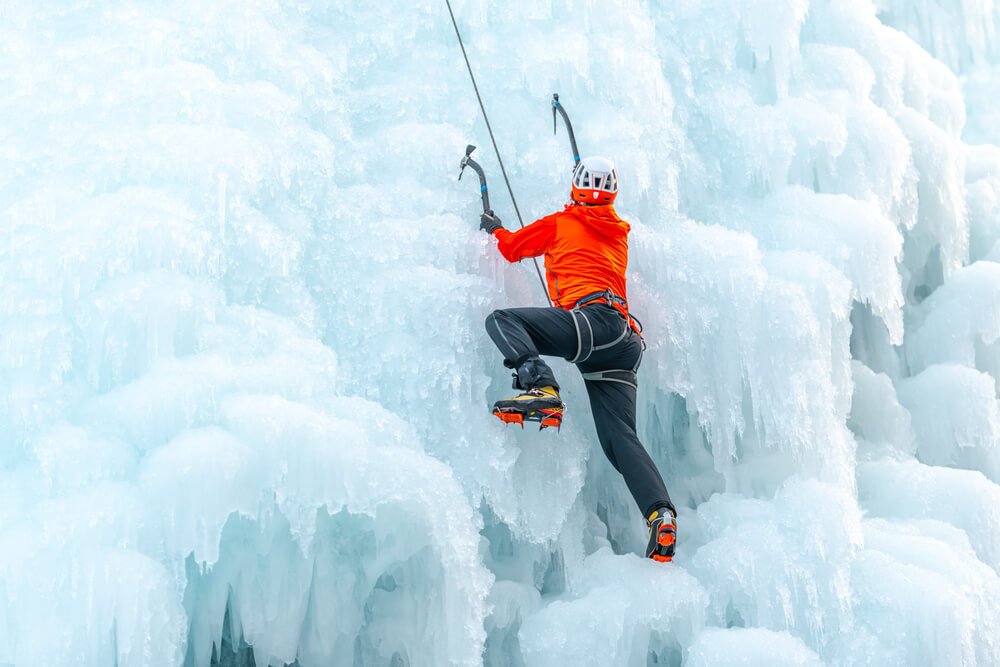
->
[586,380,676,519]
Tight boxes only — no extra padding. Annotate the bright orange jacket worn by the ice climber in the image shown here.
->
[493,204,629,315]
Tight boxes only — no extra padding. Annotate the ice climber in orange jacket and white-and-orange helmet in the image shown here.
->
[480,157,677,561]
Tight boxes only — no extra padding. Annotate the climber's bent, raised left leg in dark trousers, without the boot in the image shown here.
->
[486,308,577,391]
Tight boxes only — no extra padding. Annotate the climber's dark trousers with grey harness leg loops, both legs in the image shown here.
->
[486,302,674,517]
